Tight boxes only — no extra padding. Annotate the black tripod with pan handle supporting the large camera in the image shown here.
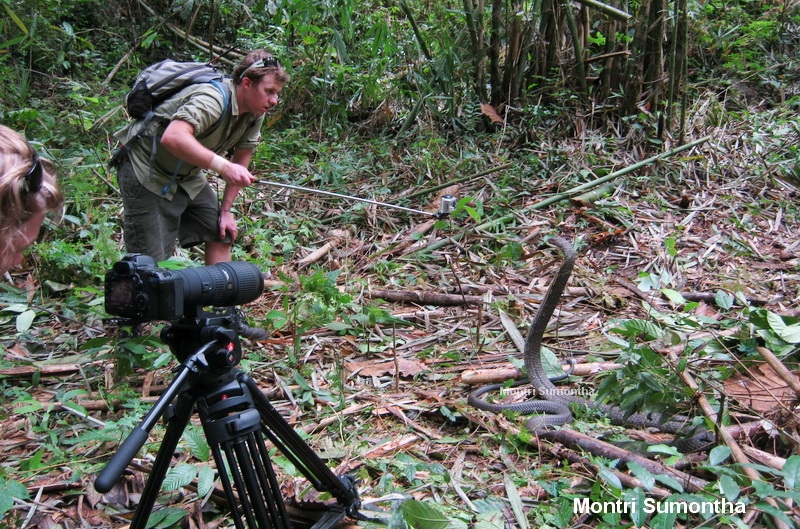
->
[94,313,367,529]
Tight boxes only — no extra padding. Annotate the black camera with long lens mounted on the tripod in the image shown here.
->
[105,254,264,321]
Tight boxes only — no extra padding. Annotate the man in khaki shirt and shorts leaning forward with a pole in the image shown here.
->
[116,50,289,339]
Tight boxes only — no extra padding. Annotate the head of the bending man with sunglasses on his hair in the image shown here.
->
[231,50,289,116]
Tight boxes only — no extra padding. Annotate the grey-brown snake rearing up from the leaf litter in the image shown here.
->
[467,236,715,453]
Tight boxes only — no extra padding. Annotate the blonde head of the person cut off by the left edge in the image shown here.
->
[0,125,64,270]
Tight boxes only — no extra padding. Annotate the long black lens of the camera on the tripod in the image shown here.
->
[176,261,264,307]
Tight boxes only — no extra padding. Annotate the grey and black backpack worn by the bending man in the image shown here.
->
[108,59,230,167]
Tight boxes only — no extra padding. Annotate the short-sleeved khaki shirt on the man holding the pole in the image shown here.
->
[114,79,264,200]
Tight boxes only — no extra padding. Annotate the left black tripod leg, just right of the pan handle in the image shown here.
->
[130,393,194,529]
